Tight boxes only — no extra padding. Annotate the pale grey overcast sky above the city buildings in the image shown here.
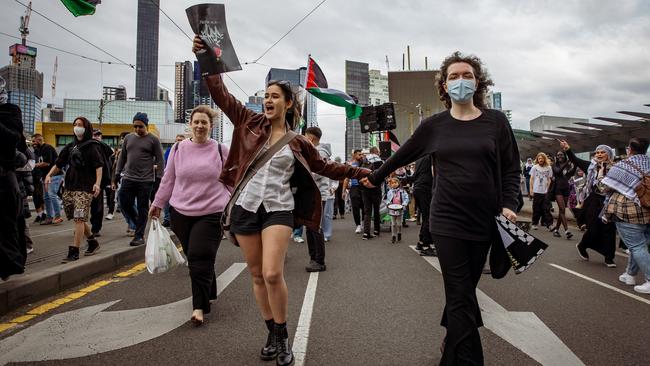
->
[0,0,650,159]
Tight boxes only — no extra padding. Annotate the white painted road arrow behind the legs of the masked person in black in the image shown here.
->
[411,245,584,366]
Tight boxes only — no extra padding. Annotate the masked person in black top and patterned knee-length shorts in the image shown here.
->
[45,117,103,263]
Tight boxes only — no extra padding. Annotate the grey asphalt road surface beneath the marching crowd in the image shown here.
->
[0,218,650,366]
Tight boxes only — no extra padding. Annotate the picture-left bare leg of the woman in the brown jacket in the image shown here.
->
[236,233,273,320]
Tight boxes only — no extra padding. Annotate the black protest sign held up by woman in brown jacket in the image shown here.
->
[185,4,241,76]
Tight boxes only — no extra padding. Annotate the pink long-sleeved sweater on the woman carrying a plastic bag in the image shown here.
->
[153,139,230,216]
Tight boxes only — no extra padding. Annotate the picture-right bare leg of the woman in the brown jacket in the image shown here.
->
[262,225,291,324]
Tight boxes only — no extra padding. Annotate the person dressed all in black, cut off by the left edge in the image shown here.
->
[0,77,27,280]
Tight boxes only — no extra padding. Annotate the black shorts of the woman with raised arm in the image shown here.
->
[230,205,293,235]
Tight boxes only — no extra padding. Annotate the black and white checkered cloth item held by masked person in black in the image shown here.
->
[496,215,548,274]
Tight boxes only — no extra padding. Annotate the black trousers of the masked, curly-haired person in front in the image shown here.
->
[432,234,490,365]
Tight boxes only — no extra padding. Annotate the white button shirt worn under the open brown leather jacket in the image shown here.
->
[236,144,295,213]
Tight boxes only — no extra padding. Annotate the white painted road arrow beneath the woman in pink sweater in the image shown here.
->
[0,263,246,365]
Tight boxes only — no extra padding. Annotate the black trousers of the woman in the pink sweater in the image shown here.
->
[169,207,222,314]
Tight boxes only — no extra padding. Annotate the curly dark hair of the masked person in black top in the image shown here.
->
[437,51,494,109]
